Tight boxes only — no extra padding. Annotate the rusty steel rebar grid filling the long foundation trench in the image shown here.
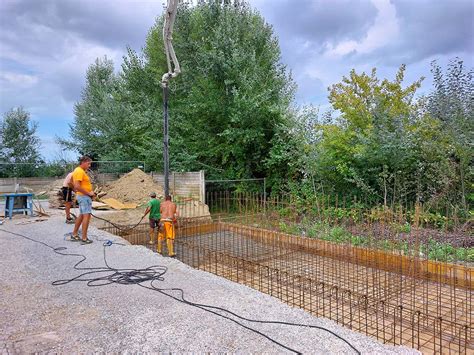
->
[102,220,474,354]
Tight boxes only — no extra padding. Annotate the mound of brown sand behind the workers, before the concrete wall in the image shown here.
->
[101,169,163,204]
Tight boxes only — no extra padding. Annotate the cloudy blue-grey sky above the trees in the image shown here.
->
[0,0,474,159]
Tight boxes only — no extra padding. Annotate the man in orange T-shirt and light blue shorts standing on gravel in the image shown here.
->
[71,156,95,244]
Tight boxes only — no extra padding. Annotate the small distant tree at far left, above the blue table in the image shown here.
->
[0,107,41,164]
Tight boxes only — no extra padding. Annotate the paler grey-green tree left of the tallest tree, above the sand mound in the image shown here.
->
[58,57,149,160]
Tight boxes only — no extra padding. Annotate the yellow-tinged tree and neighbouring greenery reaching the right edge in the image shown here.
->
[299,60,474,211]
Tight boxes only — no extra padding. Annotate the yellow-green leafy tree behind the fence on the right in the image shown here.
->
[316,65,423,203]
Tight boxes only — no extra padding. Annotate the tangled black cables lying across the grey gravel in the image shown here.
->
[0,229,361,355]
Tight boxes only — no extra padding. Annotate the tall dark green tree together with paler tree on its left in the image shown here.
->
[63,0,295,179]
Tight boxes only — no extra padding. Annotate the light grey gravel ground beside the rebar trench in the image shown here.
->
[0,214,418,354]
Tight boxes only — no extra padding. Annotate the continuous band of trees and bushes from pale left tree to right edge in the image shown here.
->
[62,0,474,217]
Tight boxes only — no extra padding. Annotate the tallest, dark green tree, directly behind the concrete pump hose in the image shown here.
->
[145,1,295,178]
